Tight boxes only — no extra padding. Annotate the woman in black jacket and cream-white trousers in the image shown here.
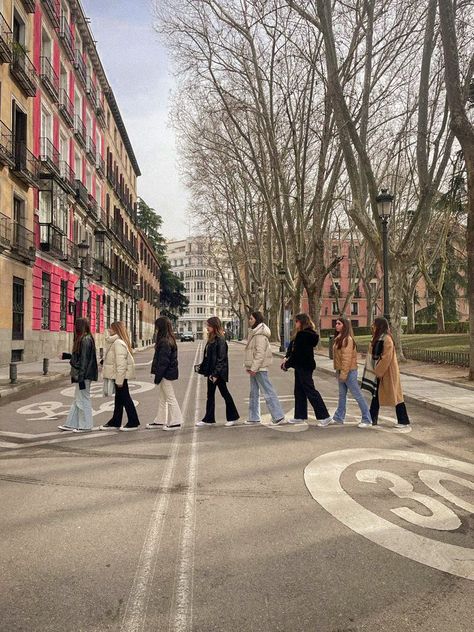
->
[146,316,183,430]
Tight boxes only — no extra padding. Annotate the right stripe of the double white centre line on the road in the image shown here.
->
[169,366,201,632]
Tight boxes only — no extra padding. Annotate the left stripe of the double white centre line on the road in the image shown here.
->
[120,345,200,632]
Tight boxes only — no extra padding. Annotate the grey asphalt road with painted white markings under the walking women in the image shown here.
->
[0,342,474,632]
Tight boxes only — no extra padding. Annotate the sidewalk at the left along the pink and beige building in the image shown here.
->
[0,347,150,405]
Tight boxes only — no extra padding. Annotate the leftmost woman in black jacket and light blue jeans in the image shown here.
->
[58,318,98,432]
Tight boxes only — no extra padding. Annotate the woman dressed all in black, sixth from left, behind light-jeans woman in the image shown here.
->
[281,314,332,426]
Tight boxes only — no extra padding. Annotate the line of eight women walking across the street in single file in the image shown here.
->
[59,311,410,432]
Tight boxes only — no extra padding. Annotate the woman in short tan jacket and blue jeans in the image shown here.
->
[330,317,372,428]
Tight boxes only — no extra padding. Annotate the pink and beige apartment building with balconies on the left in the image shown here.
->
[0,0,157,364]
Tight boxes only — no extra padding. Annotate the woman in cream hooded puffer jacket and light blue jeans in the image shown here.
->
[241,312,285,426]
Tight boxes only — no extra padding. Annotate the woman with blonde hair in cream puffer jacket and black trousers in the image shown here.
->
[100,321,140,431]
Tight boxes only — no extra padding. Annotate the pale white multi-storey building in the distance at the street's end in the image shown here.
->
[166,237,234,340]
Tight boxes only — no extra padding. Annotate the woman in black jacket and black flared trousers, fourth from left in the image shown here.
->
[196,316,239,426]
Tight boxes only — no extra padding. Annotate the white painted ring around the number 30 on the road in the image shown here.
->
[304,448,474,580]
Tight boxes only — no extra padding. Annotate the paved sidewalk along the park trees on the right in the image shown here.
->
[235,341,474,425]
